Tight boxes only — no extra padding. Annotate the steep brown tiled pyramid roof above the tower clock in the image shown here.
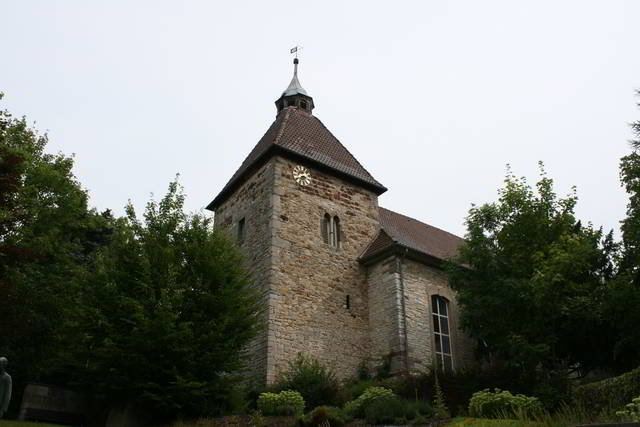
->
[207,107,387,209]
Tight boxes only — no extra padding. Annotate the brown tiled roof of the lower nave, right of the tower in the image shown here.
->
[360,207,464,260]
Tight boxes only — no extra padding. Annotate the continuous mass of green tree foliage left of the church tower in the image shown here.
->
[0,95,259,416]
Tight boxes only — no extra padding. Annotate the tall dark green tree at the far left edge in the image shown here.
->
[0,94,108,414]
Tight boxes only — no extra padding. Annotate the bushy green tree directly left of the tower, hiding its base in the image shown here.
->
[68,182,259,417]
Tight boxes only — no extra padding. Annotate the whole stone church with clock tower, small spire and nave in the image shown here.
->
[207,58,473,384]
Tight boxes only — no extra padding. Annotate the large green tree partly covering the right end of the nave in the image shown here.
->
[449,164,615,382]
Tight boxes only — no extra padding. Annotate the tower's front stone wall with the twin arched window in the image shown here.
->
[267,157,379,382]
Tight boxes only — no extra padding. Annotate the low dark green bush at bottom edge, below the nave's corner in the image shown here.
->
[364,396,433,424]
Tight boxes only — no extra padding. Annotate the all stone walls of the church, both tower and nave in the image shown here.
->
[215,152,472,383]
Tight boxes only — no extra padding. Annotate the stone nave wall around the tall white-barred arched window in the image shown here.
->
[402,259,473,372]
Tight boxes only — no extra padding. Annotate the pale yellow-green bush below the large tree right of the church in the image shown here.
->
[469,389,544,418]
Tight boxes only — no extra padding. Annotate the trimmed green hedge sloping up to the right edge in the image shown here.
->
[573,368,640,412]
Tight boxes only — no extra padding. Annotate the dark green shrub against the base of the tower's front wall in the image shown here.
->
[271,353,340,408]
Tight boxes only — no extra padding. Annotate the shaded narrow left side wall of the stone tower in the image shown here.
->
[214,160,275,384]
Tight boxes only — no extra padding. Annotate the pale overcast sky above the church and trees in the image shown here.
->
[0,0,640,235]
